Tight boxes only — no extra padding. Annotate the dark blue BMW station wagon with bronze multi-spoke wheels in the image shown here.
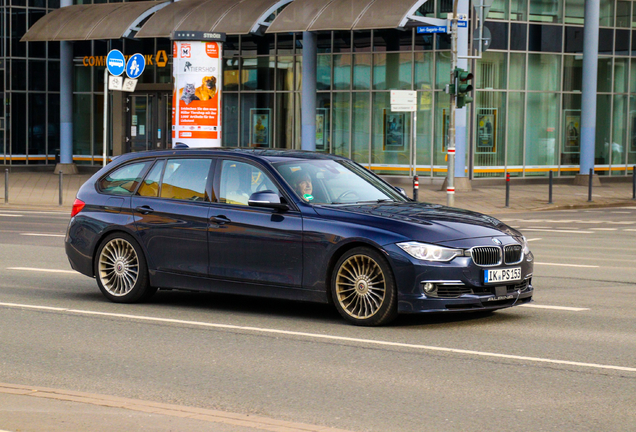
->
[66,149,533,325]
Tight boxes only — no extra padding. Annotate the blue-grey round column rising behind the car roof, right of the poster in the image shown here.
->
[300,32,318,151]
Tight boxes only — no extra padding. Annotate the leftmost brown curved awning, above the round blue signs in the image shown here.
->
[21,1,169,42]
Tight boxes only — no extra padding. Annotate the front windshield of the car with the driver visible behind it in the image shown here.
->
[274,160,407,204]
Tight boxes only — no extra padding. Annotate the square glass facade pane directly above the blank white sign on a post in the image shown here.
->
[373,53,412,90]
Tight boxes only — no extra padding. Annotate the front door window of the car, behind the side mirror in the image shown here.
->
[219,160,279,205]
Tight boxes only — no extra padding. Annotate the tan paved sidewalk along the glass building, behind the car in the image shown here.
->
[0,172,636,214]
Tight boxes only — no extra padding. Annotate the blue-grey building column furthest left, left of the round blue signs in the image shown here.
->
[55,0,77,174]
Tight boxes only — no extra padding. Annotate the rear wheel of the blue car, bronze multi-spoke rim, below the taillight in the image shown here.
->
[95,233,157,303]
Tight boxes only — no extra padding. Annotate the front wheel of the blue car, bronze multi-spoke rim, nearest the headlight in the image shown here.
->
[331,247,397,326]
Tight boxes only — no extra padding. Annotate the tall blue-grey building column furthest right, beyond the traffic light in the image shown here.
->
[574,0,600,185]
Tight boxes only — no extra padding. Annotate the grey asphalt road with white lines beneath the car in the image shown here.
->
[0,207,636,431]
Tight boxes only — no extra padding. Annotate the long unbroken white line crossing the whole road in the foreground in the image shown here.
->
[0,303,636,373]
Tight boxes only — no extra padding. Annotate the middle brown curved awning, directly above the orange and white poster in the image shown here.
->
[136,0,292,38]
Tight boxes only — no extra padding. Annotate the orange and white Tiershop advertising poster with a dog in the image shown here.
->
[172,41,222,147]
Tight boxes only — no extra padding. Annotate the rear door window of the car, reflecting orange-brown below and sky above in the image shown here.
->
[161,159,212,201]
